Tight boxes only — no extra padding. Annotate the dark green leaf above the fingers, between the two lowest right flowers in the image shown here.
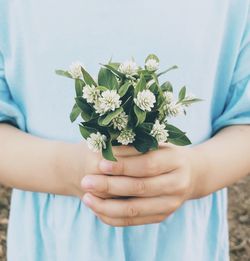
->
[133,128,158,153]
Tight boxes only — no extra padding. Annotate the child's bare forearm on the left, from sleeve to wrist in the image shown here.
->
[0,124,79,195]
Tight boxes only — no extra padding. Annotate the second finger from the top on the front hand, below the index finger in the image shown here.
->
[81,172,182,197]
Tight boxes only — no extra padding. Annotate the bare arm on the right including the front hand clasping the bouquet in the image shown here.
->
[80,126,250,226]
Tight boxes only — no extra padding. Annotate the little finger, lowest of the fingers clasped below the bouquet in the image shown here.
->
[97,212,166,227]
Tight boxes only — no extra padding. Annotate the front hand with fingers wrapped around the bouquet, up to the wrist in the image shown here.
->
[82,144,198,226]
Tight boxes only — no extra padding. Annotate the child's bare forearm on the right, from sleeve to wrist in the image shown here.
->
[191,126,250,198]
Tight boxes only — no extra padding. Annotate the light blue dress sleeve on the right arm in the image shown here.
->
[212,6,250,133]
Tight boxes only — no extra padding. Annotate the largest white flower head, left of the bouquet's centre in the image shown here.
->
[94,90,122,115]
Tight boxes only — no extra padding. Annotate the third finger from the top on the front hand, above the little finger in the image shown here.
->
[83,193,179,218]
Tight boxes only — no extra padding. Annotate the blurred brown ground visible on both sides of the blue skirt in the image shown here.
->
[0,176,250,261]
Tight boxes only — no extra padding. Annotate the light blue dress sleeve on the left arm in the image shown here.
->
[0,52,25,130]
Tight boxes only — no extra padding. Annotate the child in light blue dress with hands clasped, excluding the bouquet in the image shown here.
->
[0,0,250,261]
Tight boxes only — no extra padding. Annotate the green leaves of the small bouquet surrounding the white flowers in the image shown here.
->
[56,54,202,161]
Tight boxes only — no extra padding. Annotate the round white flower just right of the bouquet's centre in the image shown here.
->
[134,90,156,111]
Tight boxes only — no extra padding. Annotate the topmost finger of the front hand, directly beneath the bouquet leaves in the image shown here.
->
[99,147,181,177]
